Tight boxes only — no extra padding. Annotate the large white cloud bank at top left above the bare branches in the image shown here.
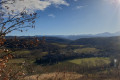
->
[2,0,69,12]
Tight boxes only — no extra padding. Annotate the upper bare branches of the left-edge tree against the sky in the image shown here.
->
[0,0,37,36]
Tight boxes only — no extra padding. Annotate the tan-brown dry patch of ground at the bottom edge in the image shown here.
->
[25,72,82,80]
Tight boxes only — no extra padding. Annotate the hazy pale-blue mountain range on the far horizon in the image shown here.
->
[36,31,120,40]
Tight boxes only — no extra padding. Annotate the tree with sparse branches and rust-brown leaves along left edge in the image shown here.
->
[0,0,37,80]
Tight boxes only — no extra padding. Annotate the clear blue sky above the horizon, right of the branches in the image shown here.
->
[9,0,120,36]
